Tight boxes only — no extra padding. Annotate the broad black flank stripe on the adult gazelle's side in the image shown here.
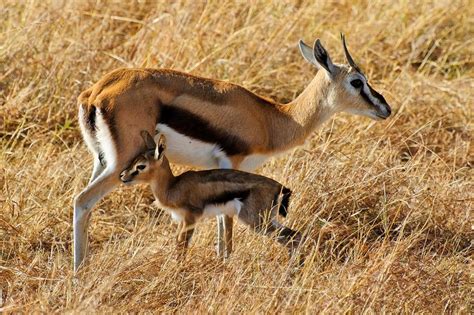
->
[158,104,250,155]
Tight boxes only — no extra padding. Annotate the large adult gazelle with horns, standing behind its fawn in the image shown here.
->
[74,37,390,270]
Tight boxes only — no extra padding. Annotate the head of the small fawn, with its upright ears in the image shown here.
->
[120,130,166,184]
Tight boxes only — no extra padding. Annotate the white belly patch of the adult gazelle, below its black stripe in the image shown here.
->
[156,124,232,169]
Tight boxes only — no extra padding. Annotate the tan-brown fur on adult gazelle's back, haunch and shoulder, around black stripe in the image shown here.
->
[79,69,302,155]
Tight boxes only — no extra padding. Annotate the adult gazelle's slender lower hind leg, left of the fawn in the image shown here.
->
[73,171,120,272]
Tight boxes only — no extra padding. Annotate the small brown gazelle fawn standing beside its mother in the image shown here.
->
[120,131,301,256]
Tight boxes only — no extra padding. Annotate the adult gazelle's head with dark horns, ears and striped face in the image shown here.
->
[299,34,391,119]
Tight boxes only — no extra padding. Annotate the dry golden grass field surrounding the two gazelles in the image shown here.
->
[0,0,474,314]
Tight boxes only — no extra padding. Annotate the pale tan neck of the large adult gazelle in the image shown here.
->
[271,70,336,149]
